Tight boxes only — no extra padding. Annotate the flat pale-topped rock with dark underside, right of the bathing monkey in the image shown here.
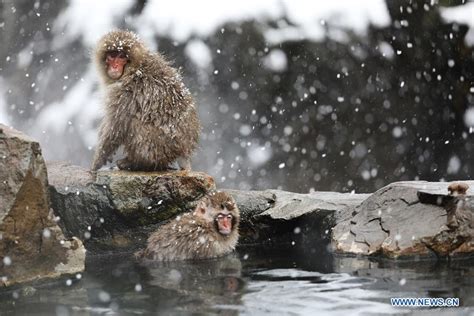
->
[226,190,369,247]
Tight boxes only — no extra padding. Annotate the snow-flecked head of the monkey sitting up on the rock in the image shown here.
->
[96,31,147,83]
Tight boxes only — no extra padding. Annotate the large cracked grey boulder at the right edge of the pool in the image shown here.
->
[333,181,474,258]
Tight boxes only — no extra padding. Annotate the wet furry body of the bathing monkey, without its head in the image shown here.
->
[137,213,238,261]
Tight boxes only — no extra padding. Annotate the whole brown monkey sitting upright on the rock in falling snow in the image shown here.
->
[91,31,201,171]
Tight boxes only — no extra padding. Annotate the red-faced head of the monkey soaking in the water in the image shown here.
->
[194,191,240,236]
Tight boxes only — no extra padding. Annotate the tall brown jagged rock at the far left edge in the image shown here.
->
[0,124,85,285]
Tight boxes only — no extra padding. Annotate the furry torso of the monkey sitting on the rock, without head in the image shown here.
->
[108,54,201,171]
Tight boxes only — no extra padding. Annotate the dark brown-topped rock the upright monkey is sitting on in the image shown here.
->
[48,162,215,253]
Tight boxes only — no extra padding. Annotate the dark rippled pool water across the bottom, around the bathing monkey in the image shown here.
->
[0,248,474,315]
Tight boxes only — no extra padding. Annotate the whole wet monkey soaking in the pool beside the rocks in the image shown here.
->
[136,191,240,261]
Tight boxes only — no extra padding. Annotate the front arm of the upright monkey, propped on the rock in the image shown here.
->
[91,117,123,171]
